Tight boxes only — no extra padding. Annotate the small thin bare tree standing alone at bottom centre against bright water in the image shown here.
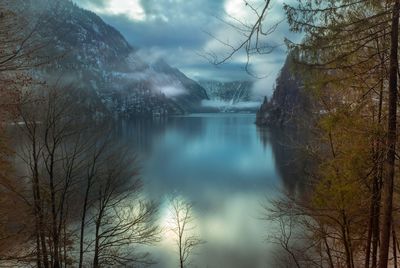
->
[170,197,205,268]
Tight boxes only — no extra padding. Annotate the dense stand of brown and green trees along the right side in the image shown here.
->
[255,0,400,268]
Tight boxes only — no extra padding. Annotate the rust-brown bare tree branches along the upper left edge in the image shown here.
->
[0,3,57,240]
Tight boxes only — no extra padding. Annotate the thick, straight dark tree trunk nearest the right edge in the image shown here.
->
[379,0,400,268]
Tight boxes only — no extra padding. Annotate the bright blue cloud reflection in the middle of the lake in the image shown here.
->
[149,121,276,182]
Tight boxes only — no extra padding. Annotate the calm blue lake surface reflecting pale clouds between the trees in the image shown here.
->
[114,114,291,268]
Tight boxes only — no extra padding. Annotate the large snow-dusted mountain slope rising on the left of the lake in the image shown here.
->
[16,0,208,117]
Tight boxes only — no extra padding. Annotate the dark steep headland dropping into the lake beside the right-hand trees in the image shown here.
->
[256,54,315,127]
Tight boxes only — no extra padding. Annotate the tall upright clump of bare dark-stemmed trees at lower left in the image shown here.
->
[17,82,87,267]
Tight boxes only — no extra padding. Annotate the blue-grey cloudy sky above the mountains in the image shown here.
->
[74,0,296,96]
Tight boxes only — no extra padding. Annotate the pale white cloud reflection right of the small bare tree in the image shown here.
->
[199,194,278,268]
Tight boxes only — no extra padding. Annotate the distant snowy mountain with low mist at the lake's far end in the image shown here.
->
[199,80,259,112]
